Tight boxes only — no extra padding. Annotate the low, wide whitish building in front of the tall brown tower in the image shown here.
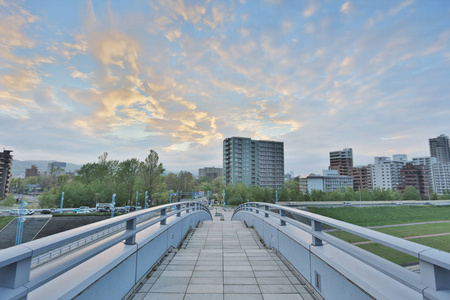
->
[307,170,353,193]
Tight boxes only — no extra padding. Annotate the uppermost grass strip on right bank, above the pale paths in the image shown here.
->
[308,205,450,227]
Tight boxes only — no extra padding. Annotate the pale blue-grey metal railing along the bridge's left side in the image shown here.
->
[0,201,212,299]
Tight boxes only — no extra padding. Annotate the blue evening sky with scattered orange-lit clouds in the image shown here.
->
[0,0,450,175]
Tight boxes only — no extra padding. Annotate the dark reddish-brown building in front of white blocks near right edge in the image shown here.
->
[397,163,430,199]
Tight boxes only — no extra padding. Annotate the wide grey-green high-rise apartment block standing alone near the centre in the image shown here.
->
[223,137,284,188]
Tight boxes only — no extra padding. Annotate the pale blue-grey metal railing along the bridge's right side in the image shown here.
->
[232,202,450,299]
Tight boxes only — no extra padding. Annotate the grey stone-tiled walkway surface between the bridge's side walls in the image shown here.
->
[128,221,314,300]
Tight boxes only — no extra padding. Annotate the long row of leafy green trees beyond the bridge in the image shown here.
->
[2,150,446,207]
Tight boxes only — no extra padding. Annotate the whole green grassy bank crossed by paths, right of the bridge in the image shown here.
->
[309,206,450,264]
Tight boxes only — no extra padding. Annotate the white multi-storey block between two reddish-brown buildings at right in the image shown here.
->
[370,154,407,191]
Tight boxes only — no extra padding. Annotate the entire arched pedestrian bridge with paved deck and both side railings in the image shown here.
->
[0,201,450,300]
